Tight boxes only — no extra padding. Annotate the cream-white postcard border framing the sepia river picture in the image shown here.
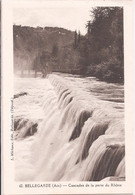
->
[1,0,133,195]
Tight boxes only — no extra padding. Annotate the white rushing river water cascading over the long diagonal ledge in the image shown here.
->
[14,74,125,181]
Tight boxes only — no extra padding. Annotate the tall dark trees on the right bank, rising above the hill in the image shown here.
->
[80,7,124,82]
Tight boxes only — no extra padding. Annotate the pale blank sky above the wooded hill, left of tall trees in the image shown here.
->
[13,0,92,35]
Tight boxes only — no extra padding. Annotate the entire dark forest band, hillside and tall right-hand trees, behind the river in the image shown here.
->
[13,7,124,82]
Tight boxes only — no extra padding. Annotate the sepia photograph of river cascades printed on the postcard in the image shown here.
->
[1,0,132,194]
